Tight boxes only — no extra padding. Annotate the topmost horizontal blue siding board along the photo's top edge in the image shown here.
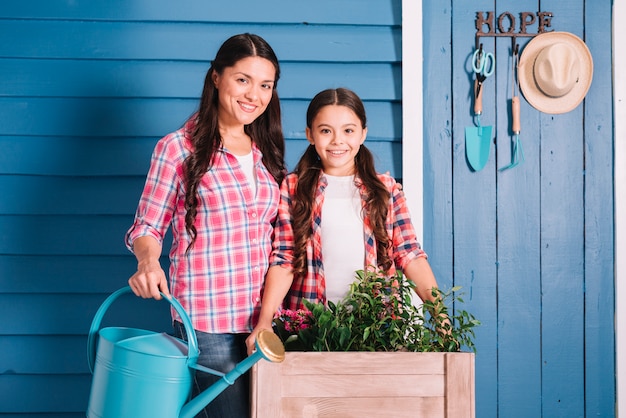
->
[0,0,401,26]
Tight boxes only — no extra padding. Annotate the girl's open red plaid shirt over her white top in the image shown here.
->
[270,173,426,310]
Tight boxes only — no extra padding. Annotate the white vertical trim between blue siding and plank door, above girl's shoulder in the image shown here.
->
[402,0,424,245]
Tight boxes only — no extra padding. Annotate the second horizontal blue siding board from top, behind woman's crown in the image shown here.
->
[0,19,401,62]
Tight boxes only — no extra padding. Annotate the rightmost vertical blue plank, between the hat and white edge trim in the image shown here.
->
[584,0,624,417]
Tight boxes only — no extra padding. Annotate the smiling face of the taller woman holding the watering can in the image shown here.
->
[213,57,276,127]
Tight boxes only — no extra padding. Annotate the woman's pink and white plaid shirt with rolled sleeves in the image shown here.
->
[126,118,280,333]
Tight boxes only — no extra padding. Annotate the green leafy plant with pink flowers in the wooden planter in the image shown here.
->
[274,270,480,352]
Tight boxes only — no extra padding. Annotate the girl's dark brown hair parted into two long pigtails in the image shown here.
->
[293,88,392,275]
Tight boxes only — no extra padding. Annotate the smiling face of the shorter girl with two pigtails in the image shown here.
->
[306,105,367,176]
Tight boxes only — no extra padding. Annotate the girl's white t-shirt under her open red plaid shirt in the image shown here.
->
[321,174,365,302]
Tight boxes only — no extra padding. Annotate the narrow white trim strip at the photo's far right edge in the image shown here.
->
[613,1,626,418]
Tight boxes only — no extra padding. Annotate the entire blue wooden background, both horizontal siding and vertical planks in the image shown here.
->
[0,0,615,418]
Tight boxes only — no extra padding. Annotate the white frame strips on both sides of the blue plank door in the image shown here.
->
[402,0,626,418]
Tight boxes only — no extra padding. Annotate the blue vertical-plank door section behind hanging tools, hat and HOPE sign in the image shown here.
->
[423,0,615,418]
